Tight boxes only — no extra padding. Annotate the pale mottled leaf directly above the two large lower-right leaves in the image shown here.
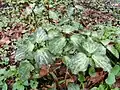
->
[83,38,99,53]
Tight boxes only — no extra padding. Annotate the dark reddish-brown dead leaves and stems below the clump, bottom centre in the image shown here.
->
[39,59,77,90]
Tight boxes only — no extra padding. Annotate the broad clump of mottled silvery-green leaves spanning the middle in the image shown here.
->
[16,22,120,74]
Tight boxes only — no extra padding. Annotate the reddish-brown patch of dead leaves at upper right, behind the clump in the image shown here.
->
[81,9,116,29]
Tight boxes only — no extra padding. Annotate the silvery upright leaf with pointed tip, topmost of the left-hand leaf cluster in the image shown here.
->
[34,27,48,43]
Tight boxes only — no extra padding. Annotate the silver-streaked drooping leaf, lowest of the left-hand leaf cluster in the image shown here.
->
[34,48,53,67]
